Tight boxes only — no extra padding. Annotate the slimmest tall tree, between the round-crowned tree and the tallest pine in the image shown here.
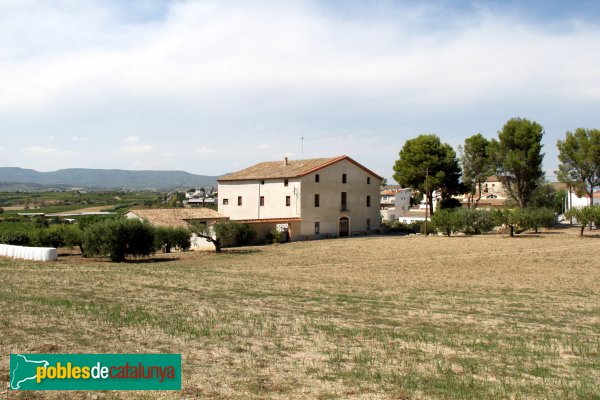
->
[459,133,494,208]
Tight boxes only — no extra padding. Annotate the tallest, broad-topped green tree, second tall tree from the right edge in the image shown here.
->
[490,118,544,208]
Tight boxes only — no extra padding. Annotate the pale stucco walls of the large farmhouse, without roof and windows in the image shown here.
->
[218,160,381,238]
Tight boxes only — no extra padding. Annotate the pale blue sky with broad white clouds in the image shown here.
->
[0,0,600,180]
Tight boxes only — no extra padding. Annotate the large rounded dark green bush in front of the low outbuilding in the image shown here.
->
[83,219,155,262]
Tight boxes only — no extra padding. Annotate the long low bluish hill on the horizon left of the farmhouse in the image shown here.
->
[0,167,218,191]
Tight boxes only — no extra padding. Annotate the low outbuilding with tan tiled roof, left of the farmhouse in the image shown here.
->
[125,208,228,250]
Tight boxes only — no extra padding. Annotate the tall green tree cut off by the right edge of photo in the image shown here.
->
[556,128,600,205]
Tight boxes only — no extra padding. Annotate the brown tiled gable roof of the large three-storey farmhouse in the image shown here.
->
[218,156,382,182]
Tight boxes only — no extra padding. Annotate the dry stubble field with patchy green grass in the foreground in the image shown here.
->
[0,229,600,399]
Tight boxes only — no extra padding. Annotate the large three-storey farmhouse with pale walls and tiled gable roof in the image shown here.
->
[218,156,382,240]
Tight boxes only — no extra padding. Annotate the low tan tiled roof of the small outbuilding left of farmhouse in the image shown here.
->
[129,208,228,228]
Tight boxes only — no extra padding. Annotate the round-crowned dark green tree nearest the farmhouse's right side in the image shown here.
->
[394,135,462,215]
